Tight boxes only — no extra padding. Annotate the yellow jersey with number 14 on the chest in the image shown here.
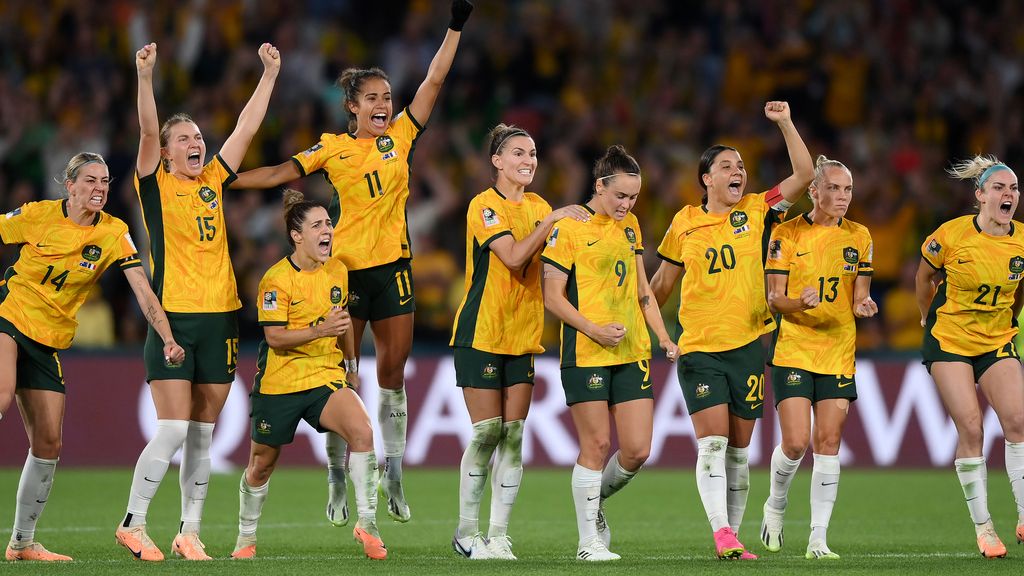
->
[0,200,142,349]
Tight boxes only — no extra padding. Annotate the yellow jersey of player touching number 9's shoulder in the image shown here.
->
[449,188,551,356]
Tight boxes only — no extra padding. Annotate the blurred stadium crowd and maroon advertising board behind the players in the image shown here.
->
[0,0,1024,465]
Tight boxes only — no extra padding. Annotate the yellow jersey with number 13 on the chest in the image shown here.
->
[765,214,873,374]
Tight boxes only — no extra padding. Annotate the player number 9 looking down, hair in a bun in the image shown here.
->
[541,146,679,562]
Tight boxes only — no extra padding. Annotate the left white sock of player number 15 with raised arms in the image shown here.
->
[122,420,188,528]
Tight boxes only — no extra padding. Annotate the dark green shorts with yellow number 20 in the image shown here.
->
[676,340,765,414]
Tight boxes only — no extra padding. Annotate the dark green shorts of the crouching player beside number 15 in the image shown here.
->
[249,384,340,446]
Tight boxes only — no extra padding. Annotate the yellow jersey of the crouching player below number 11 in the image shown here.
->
[255,257,348,395]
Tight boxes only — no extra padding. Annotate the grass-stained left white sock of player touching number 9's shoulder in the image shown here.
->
[456,416,502,538]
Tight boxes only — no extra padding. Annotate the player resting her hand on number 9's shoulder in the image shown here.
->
[450,124,590,560]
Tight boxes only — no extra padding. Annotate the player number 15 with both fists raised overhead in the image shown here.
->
[116,44,281,561]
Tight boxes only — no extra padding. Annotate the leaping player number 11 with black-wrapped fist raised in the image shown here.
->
[231,0,473,526]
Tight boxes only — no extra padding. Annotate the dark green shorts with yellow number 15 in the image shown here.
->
[142,312,239,384]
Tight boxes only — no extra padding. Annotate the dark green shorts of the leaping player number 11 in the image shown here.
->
[348,258,416,321]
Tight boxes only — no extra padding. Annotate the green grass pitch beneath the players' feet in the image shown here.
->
[0,462,1024,576]
